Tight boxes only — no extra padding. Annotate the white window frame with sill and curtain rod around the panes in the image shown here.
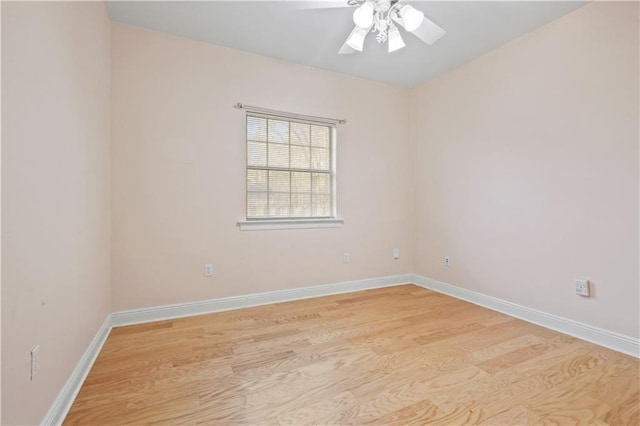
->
[237,108,345,231]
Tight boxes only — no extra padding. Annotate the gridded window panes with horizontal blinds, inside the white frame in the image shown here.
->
[246,112,336,226]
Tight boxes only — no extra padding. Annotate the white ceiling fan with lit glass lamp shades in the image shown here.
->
[338,0,446,54]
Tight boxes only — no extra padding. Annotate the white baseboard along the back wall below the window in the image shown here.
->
[111,274,411,327]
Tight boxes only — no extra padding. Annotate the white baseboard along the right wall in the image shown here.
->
[410,274,640,358]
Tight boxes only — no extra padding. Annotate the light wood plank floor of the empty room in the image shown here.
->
[65,285,640,425]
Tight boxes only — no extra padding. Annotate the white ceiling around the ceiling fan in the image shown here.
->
[106,0,587,87]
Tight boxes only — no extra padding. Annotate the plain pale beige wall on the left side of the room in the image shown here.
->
[2,2,110,425]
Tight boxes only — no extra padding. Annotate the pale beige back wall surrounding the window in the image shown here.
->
[111,24,411,311]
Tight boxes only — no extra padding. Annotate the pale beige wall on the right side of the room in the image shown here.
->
[411,2,640,338]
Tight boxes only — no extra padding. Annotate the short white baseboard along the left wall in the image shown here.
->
[40,314,111,426]
